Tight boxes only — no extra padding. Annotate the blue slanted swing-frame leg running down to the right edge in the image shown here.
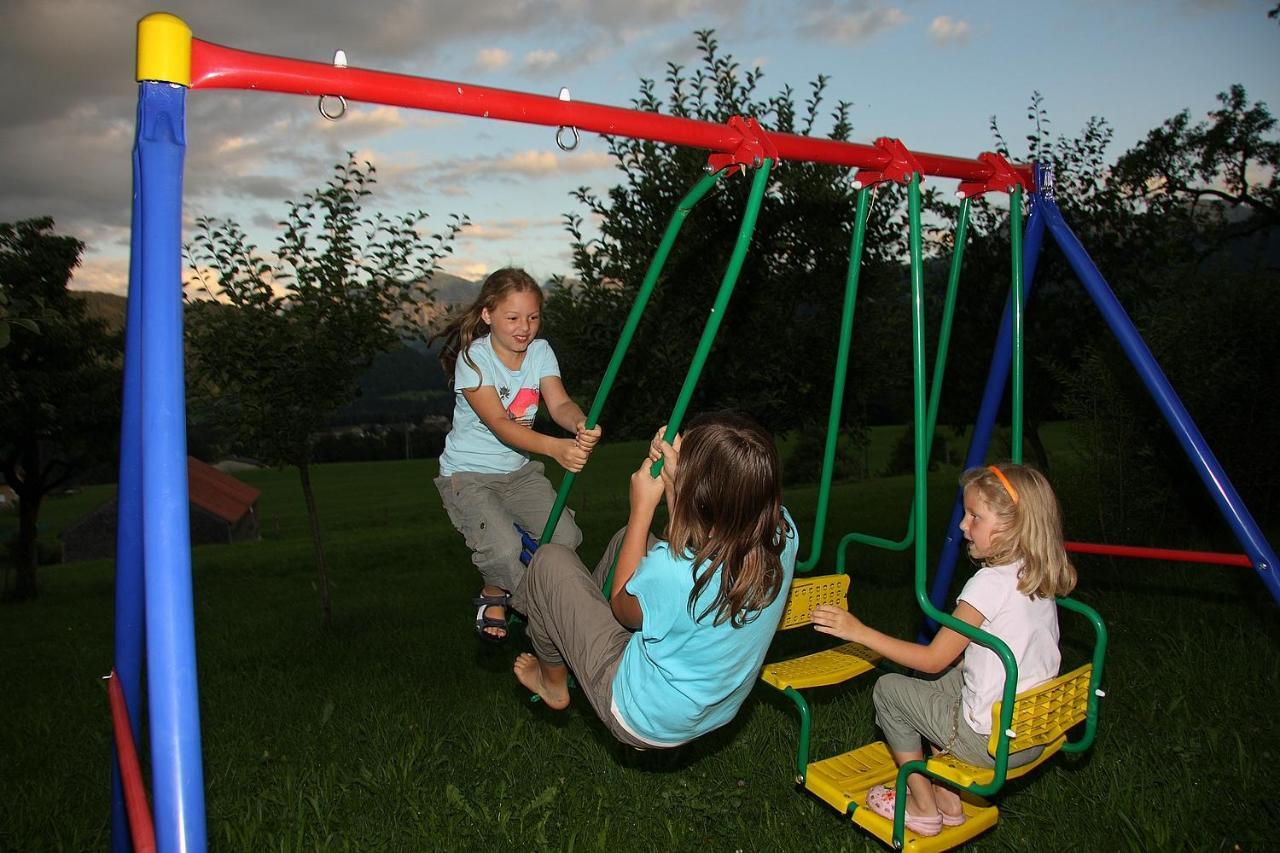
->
[1039,199,1280,602]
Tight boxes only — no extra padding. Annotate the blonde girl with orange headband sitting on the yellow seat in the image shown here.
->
[813,464,1075,835]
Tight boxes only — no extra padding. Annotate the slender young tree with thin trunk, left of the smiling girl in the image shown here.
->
[187,154,467,624]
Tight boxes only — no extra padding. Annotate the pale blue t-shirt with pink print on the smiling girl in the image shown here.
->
[440,334,559,476]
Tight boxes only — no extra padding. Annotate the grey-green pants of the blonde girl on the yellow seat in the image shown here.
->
[872,666,1043,767]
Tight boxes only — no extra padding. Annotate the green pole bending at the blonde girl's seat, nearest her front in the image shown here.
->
[893,173,1018,849]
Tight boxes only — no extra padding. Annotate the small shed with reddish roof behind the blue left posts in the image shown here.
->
[61,456,261,562]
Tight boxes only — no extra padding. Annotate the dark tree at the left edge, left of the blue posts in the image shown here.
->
[0,218,120,599]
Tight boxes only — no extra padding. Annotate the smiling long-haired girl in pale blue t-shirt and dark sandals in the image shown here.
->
[435,268,600,642]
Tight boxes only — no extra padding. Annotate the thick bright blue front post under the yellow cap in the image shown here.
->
[137,82,207,850]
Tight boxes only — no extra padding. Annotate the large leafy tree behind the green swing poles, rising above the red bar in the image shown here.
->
[545,31,926,435]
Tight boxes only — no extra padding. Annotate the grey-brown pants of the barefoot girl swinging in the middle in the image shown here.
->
[511,528,657,749]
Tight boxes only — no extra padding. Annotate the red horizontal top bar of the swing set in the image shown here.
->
[191,38,1032,190]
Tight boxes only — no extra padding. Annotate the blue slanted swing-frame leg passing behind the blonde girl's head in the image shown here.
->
[919,196,1044,630]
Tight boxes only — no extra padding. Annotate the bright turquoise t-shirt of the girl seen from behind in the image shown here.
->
[613,508,800,745]
